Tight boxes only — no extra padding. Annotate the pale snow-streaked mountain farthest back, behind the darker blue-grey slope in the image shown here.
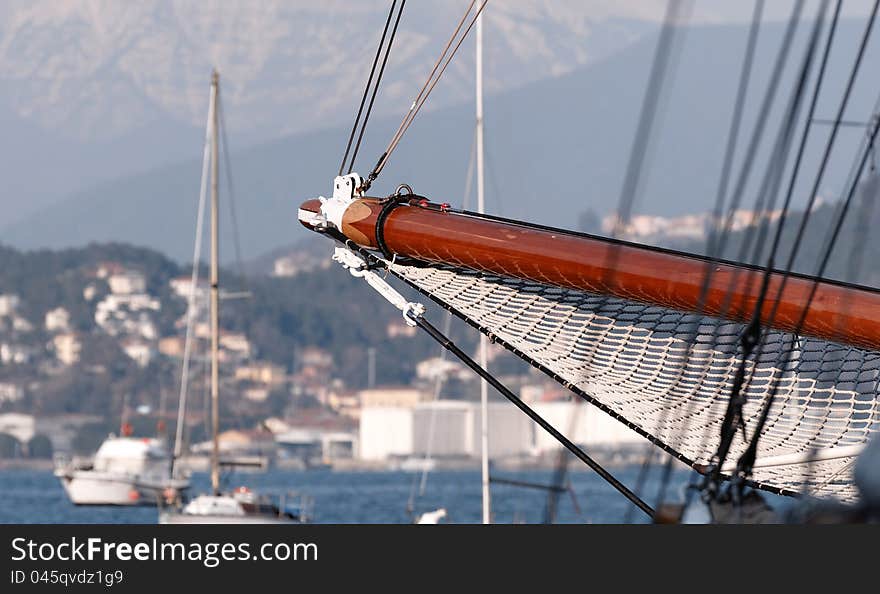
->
[0,0,676,225]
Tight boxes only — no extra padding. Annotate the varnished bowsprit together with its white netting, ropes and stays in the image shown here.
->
[299,0,880,514]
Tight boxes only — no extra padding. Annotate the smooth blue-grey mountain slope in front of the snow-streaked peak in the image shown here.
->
[3,13,880,259]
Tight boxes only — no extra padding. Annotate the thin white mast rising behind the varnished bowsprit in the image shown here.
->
[476,12,492,524]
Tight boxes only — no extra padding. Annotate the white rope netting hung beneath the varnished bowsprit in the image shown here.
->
[391,264,880,501]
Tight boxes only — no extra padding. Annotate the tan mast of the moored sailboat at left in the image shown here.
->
[211,70,220,495]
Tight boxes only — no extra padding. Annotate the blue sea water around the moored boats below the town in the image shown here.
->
[0,466,690,524]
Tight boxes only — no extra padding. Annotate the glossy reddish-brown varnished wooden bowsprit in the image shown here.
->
[301,198,880,350]
